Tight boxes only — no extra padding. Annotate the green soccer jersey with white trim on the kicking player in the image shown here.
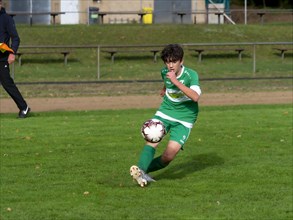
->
[156,66,200,128]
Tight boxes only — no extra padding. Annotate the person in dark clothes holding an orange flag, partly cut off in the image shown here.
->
[0,0,30,118]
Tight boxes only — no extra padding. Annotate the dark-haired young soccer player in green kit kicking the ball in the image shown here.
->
[130,44,201,187]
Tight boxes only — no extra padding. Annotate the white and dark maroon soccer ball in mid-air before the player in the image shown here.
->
[141,119,166,143]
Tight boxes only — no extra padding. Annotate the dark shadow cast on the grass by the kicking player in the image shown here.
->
[151,153,224,180]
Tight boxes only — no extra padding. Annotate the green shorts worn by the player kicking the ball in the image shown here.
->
[154,115,191,149]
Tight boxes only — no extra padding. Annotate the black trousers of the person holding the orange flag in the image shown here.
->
[0,62,27,110]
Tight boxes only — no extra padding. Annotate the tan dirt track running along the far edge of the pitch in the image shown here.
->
[0,91,292,113]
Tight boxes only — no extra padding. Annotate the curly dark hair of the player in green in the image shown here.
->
[161,44,184,63]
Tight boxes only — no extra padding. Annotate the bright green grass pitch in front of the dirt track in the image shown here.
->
[0,105,293,220]
